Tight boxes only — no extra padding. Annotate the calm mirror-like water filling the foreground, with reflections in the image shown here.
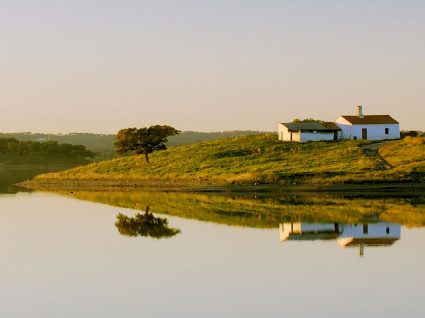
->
[0,186,425,318]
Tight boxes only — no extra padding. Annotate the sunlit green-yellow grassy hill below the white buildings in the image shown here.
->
[24,134,425,186]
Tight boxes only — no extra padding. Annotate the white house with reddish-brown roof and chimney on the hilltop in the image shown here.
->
[336,106,400,140]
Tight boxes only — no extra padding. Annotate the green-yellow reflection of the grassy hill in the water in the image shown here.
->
[62,191,425,229]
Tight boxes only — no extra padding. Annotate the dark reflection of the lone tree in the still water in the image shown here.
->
[115,206,181,239]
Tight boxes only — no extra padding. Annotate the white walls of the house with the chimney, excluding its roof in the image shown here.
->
[336,117,400,140]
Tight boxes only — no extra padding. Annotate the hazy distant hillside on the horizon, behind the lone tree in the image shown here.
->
[0,130,260,161]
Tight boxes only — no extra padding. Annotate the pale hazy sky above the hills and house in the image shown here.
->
[0,0,425,133]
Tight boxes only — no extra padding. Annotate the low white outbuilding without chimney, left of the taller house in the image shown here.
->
[278,122,341,142]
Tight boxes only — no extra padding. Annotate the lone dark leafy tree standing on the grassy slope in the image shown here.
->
[115,125,180,162]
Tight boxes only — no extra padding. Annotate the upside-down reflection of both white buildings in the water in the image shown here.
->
[279,222,401,256]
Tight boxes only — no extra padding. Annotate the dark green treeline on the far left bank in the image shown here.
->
[0,138,95,159]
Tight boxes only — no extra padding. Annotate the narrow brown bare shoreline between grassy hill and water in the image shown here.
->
[15,180,425,196]
